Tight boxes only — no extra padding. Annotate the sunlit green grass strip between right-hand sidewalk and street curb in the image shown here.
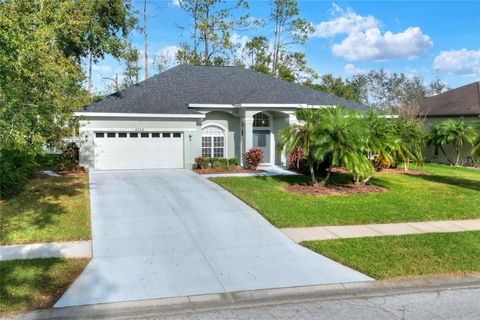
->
[303,231,480,279]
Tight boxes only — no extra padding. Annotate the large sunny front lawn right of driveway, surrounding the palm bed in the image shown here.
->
[212,164,480,227]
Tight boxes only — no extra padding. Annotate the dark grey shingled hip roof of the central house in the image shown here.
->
[79,65,365,114]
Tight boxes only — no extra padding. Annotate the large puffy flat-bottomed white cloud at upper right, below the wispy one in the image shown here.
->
[332,27,433,61]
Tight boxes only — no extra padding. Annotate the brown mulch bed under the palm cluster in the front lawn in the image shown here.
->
[285,184,388,196]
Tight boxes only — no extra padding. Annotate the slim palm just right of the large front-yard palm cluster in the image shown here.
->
[394,115,425,171]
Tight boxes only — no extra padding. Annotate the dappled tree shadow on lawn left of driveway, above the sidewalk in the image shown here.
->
[0,176,87,243]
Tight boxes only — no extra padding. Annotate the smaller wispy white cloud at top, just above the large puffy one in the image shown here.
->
[313,4,380,38]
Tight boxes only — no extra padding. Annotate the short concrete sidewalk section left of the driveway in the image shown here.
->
[0,241,92,261]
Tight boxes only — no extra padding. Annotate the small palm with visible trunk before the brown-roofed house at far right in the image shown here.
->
[432,117,477,166]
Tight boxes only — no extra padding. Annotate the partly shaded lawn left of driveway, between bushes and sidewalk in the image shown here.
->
[0,175,91,244]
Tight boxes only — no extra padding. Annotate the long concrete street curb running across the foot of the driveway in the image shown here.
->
[6,273,480,320]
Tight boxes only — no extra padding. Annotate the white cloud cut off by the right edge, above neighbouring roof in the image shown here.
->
[433,49,480,76]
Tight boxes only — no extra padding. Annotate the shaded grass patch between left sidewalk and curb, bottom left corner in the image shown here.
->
[0,258,89,312]
